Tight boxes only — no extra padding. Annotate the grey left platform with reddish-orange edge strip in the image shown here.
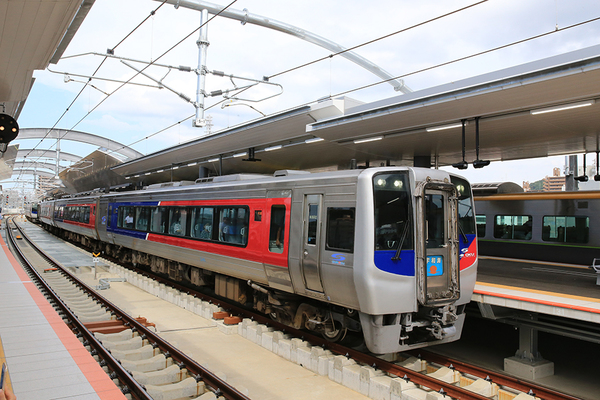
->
[0,225,125,400]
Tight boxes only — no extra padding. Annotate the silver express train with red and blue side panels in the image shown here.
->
[40,167,477,354]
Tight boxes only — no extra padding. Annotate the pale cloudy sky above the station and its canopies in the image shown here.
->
[14,0,600,189]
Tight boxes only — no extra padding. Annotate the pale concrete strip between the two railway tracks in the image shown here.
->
[7,222,367,400]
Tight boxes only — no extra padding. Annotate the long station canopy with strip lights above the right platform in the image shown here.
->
[112,46,600,184]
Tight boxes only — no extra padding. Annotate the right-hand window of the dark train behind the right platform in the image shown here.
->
[542,215,590,243]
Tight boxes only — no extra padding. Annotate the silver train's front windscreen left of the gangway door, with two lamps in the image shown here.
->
[373,173,413,250]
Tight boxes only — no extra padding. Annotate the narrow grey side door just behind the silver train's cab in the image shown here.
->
[300,194,323,292]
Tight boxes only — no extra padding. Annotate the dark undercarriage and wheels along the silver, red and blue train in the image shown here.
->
[49,224,464,353]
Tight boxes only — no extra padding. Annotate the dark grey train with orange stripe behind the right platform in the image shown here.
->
[473,185,600,266]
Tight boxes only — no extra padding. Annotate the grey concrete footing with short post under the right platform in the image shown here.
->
[504,317,554,380]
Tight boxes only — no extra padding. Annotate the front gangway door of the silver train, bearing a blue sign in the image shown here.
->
[415,181,460,306]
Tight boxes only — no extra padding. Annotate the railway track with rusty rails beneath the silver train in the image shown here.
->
[10,219,576,400]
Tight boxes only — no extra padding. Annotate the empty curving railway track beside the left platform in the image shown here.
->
[6,220,248,400]
